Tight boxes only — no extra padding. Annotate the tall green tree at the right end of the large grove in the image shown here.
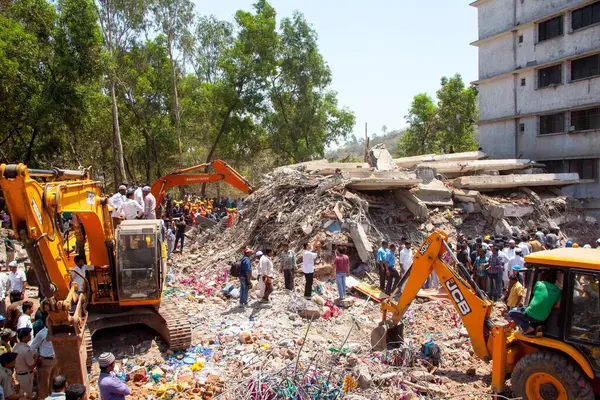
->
[265,12,354,163]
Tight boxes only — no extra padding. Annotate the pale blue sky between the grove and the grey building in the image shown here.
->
[194,0,478,143]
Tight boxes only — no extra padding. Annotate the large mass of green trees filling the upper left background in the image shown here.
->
[0,0,354,194]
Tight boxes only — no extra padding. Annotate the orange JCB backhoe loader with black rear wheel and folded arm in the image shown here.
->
[371,232,600,400]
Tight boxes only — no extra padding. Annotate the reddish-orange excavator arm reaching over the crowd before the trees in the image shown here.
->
[151,160,253,210]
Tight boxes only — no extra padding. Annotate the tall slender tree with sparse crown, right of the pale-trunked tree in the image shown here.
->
[152,0,194,167]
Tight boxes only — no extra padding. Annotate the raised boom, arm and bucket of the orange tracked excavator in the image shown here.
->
[0,164,115,384]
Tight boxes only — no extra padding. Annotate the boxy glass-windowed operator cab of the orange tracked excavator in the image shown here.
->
[115,220,166,302]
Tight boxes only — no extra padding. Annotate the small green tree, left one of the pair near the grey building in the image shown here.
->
[398,93,440,156]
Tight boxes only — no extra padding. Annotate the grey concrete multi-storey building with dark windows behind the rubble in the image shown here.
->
[471,0,600,211]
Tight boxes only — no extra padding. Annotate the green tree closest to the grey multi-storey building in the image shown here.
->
[437,74,478,152]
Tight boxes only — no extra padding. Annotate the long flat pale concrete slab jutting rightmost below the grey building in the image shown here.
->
[454,173,593,191]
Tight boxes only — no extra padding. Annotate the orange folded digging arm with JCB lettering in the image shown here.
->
[381,232,493,361]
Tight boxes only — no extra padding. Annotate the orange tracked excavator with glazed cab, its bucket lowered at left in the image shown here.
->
[0,164,191,390]
